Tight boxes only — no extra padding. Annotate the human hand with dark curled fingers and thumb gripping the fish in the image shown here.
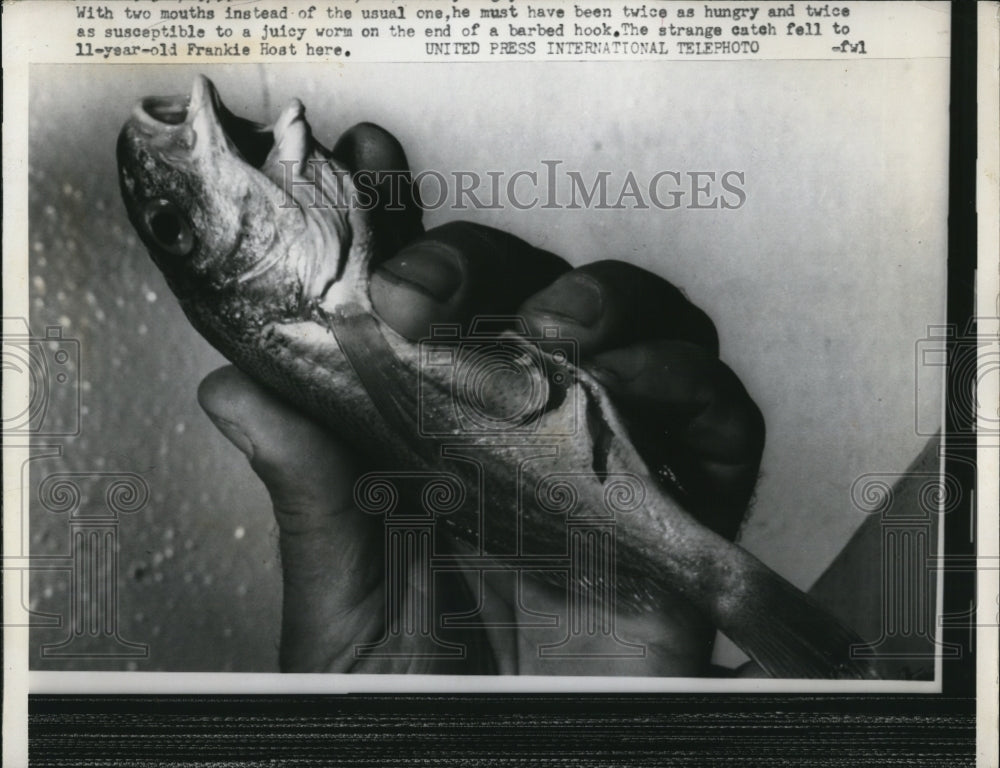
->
[199,125,764,675]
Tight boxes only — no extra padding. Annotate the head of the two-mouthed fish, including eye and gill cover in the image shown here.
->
[117,76,369,353]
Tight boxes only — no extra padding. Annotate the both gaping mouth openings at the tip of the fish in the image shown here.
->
[133,75,280,170]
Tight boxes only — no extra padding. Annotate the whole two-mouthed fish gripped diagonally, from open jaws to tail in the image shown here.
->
[117,76,878,679]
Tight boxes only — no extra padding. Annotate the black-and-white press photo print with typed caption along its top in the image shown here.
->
[4,0,997,765]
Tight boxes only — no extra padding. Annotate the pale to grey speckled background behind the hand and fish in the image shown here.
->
[27,60,947,671]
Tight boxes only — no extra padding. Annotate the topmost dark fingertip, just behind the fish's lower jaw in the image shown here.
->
[331,123,424,263]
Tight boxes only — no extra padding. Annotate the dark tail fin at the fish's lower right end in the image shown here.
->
[716,555,879,680]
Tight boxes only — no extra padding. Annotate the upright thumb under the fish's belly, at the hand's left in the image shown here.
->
[198,367,382,670]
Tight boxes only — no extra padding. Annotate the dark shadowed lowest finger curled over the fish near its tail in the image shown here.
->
[589,341,765,536]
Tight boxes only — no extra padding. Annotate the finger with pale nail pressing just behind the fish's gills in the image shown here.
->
[370,222,569,340]
